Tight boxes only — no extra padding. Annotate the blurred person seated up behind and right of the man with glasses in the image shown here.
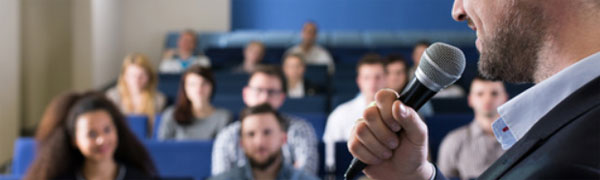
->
[282,54,322,98]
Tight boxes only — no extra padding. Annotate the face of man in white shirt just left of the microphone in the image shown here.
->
[385,55,409,93]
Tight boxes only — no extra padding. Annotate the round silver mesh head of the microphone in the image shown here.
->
[415,42,466,92]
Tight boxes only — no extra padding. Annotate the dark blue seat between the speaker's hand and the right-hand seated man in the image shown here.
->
[425,114,473,162]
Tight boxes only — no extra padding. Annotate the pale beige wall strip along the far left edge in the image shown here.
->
[0,0,21,162]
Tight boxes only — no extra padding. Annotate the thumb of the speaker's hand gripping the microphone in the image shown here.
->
[392,101,427,146]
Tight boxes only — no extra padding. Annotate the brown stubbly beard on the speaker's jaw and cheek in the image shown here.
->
[478,1,548,83]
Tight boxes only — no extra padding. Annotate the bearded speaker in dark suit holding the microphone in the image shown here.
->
[348,0,600,179]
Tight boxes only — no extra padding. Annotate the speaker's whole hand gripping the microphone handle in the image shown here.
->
[348,89,435,179]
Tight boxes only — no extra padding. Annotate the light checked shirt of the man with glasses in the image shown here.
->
[211,115,319,175]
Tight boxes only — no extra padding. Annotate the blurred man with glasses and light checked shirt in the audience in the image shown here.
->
[212,66,319,175]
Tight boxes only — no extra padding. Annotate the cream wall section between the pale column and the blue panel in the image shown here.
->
[121,0,231,65]
